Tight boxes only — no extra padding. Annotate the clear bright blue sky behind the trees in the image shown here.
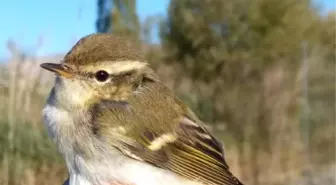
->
[0,0,336,58]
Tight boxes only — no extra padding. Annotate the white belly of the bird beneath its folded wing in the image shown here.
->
[70,155,201,185]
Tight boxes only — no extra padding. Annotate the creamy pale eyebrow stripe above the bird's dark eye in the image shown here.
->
[81,61,148,74]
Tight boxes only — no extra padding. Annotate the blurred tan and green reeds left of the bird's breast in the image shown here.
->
[0,50,67,185]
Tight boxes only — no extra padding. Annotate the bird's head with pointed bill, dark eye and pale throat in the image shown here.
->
[41,34,157,109]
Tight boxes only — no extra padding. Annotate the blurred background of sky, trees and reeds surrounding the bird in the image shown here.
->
[0,0,336,185]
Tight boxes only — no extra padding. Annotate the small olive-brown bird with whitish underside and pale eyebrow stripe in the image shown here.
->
[40,33,242,185]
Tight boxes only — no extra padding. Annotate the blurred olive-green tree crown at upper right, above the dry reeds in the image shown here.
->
[161,0,317,81]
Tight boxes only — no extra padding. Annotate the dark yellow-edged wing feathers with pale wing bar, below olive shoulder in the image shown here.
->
[95,100,242,185]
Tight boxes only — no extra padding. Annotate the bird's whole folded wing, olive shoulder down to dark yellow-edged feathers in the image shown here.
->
[93,88,242,185]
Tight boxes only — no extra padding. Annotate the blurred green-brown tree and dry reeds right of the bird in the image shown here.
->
[160,0,336,184]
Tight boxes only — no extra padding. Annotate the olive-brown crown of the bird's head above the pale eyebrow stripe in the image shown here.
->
[63,34,144,66]
